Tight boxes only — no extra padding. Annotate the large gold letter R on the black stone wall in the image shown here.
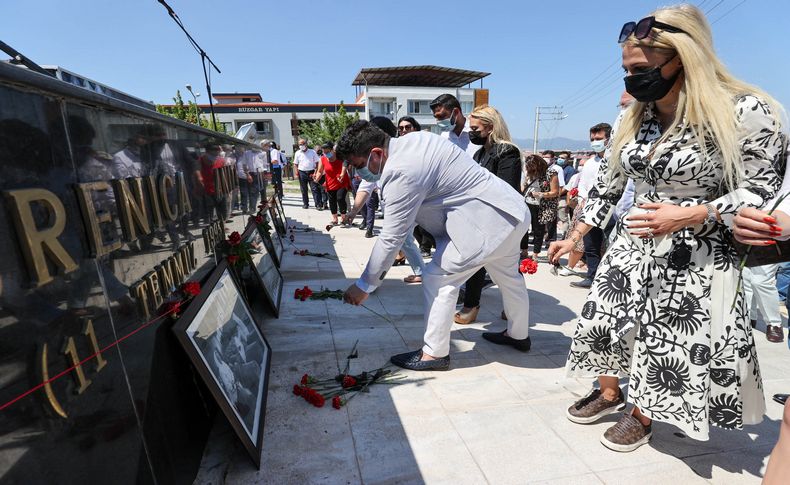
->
[4,189,77,287]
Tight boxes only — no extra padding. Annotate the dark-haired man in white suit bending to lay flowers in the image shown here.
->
[337,121,530,370]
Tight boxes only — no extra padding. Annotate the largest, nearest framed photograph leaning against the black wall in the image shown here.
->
[173,261,272,468]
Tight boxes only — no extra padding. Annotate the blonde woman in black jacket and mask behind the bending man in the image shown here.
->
[455,105,522,325]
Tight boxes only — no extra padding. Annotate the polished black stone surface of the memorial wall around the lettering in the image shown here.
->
[0,65,266,484]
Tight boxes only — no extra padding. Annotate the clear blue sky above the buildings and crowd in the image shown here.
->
[0,0,790,139]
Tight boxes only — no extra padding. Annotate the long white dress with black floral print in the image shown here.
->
[566,95,785,440]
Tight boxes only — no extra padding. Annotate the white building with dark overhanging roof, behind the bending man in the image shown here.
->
[352,66,489,131]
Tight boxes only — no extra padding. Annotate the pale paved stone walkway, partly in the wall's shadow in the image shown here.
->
[196,196,790,485]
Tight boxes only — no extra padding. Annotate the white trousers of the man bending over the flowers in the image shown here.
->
[422,216,529,357]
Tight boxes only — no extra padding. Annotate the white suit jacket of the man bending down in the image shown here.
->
[356,132,528,293]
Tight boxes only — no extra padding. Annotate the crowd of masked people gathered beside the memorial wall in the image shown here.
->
[286,5,790,474]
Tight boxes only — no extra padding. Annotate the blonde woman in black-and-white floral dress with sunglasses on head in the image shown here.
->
[549,5,785,451]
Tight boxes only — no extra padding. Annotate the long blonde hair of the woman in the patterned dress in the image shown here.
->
[608,5,783,190]
